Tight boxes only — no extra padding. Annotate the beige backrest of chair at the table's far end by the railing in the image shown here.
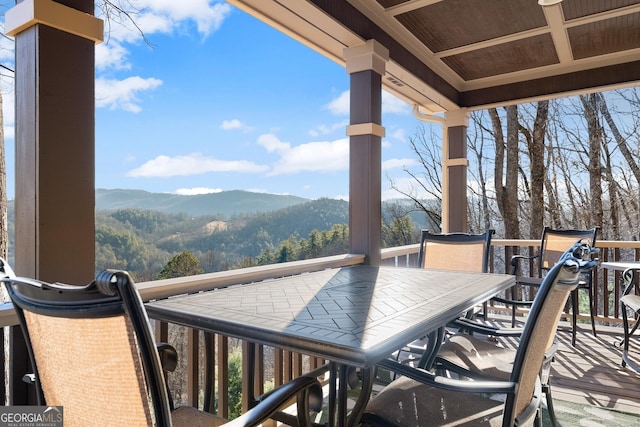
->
[418,230,494,273]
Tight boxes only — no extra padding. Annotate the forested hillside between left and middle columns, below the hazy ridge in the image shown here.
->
[96,199,348,280]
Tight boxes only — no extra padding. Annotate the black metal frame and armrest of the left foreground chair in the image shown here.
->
[0,259,322,426]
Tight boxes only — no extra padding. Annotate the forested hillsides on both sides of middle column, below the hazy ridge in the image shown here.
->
[96,199,430,281]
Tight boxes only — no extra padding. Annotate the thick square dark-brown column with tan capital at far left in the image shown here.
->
[5,0,103,284]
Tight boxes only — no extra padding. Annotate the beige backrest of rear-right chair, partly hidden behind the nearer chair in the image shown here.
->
[538,227,598,277]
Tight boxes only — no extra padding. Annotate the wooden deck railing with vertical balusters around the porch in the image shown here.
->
[0,244,640,416]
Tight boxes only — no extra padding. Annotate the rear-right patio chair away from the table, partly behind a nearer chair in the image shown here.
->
[492,227,598,346]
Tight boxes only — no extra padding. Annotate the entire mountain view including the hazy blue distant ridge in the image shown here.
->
[9,189,425,281]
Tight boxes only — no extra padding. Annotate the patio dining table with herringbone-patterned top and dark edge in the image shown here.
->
[146,265,514,426]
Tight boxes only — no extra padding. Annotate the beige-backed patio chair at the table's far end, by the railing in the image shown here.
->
[397,230,494,367]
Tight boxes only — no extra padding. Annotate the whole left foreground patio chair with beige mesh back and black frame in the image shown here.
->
[0,260,322,427]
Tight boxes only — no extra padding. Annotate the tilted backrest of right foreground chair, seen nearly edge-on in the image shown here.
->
[503,243,597,425]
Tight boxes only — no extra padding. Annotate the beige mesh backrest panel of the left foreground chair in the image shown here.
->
[24,311,151,427]
